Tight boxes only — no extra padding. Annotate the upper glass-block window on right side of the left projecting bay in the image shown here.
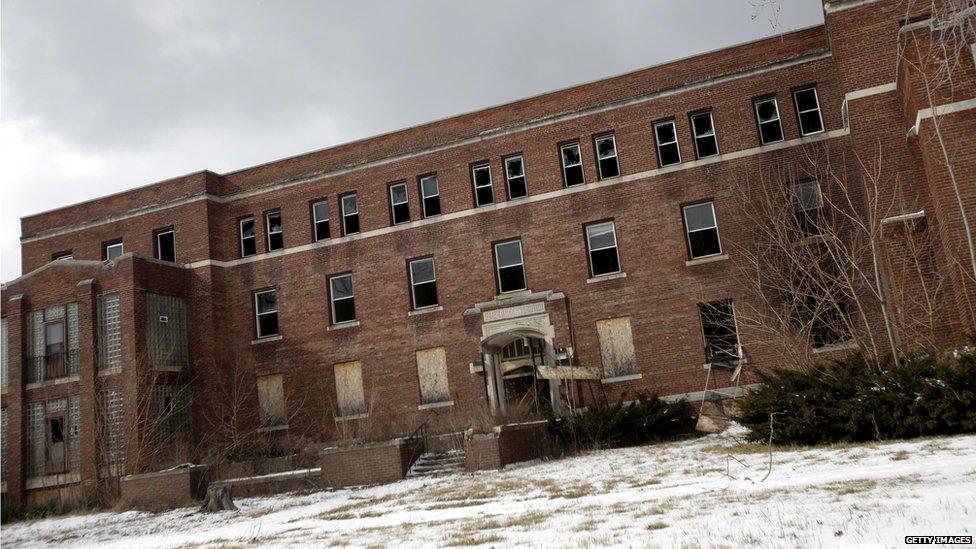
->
[146,293,187,371]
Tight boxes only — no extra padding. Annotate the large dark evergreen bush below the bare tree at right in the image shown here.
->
[735,353,976,444]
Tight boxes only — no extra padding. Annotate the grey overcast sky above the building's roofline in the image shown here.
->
[0,0,823,281]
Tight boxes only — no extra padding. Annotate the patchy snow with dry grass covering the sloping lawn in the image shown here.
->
[0,431,976,549]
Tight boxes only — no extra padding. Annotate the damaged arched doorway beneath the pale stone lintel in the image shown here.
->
[481,328,559,412]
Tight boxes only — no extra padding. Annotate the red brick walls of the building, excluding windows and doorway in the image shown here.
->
[2,0,976,506]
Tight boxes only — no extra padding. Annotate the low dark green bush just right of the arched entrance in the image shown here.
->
[549,394,694,449]
